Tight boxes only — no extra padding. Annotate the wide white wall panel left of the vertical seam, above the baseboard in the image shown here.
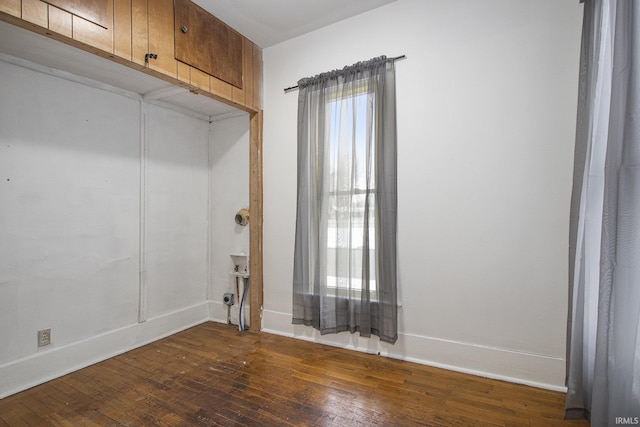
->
[0,62,139,364]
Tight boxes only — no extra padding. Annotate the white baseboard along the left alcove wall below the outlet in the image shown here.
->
[0,302,209,399]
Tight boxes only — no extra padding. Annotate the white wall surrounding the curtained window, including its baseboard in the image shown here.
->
[263,0,582,389]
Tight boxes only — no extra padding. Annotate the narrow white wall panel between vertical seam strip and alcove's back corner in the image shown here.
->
[144,106,209,318]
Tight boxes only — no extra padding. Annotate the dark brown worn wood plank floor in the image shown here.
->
[0,322,588,426]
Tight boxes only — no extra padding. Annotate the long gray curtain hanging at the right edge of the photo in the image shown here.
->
[565,0,640,426]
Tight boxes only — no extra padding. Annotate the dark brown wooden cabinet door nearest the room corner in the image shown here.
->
[175,0,243,89]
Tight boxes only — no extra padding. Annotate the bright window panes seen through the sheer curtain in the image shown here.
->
[325,93,376,297]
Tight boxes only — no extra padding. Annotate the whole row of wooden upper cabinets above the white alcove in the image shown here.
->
[0,0,262,112]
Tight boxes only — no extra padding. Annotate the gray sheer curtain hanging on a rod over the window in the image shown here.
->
[293,57,398,343]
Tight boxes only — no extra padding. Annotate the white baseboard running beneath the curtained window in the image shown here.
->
[262,310,567,392]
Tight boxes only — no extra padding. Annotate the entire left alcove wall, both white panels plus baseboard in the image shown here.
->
[0,61,222,398]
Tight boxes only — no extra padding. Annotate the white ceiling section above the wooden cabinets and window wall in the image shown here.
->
[193,0,396,49]
